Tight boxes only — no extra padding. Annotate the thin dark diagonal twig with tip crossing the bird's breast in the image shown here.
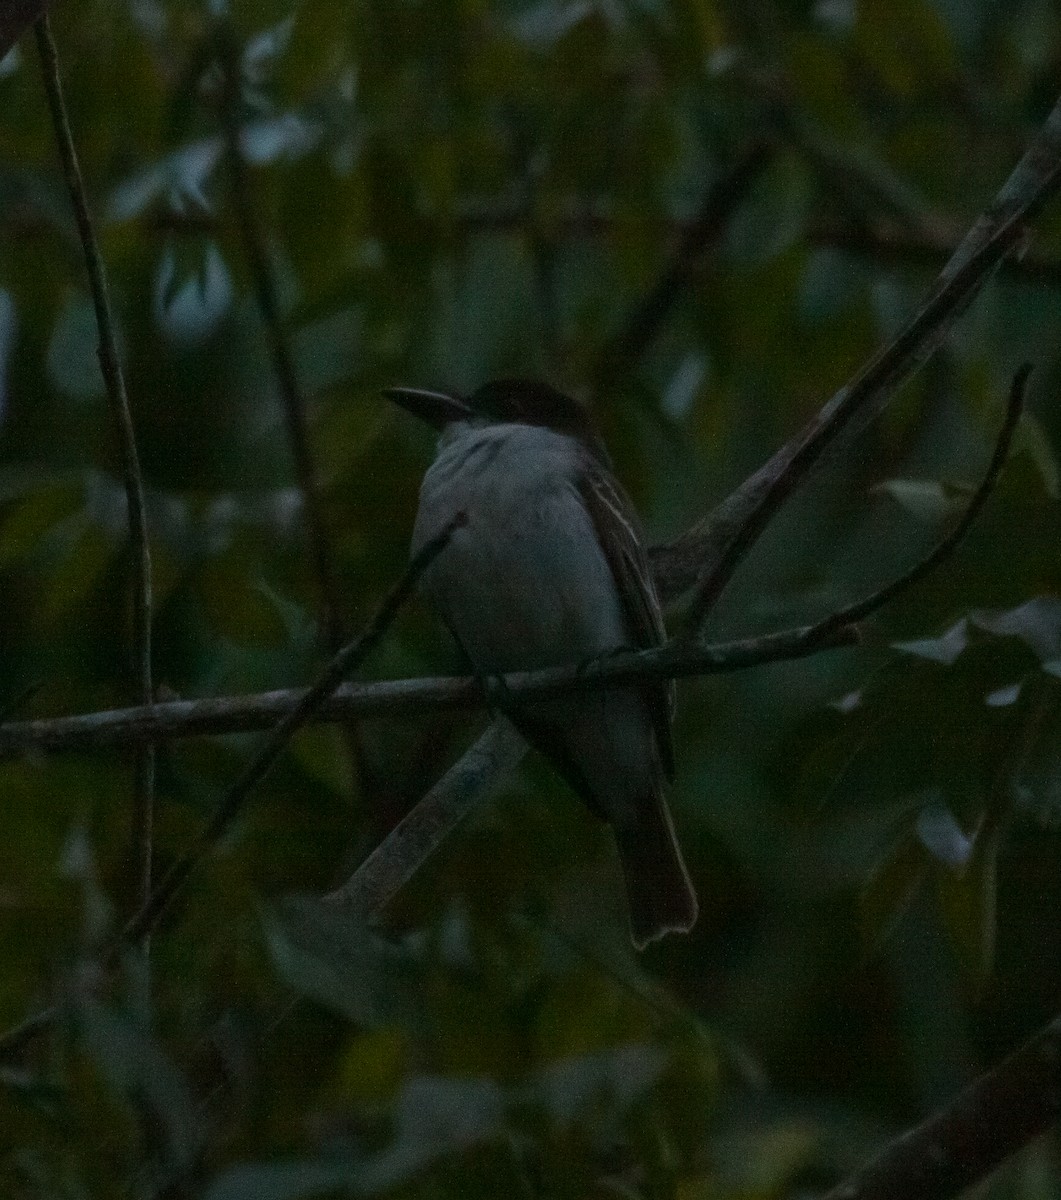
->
[0,522,457,1055]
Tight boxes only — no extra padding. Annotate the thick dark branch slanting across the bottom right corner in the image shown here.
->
[822,1016,1061,1200]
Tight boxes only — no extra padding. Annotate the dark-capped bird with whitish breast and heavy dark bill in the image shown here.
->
[384,378,697,950]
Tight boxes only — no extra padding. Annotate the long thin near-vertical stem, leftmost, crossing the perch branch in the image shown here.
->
[35,12,155,931]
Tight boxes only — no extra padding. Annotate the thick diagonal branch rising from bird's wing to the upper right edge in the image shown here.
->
[653,92,1061,626]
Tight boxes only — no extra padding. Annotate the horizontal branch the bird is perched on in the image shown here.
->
[0,625,858,757]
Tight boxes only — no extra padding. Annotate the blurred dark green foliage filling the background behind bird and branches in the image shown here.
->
[0,0,1061,1200]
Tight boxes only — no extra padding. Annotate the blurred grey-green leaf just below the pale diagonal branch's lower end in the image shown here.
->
[263,896,424,1028]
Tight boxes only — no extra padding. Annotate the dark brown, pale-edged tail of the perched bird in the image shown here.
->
[615,792,699,950]
